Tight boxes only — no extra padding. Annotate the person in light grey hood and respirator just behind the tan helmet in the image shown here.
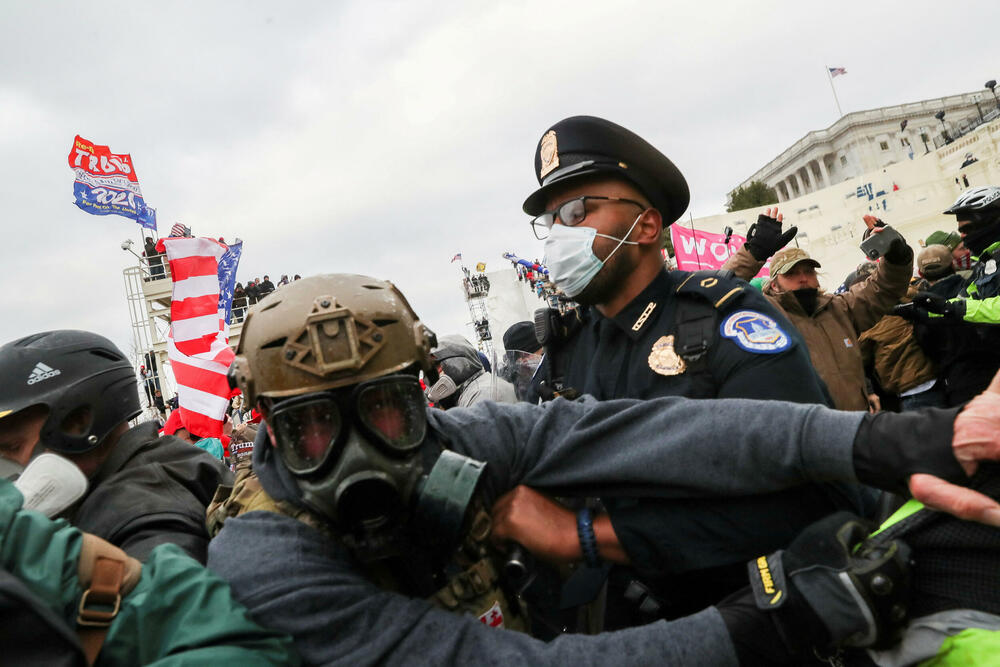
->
[427,335,517,409]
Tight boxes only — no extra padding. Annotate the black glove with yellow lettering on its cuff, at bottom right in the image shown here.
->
[740,512,910,655]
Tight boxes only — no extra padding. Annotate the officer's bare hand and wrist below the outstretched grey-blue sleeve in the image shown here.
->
[492,485,628,564]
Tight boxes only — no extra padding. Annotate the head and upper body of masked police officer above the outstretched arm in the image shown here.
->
[523,116,825,403]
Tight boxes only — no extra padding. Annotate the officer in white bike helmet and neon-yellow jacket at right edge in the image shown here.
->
[900,186,1000,405]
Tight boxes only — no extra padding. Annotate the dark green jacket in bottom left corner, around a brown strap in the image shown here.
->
[0,480,299,666]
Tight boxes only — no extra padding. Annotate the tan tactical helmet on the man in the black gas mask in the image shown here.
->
[236,273,437,405]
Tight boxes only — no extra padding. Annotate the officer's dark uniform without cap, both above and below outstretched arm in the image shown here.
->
[552,271,871,629]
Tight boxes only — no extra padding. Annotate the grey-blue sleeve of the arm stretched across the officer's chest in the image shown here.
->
[428,397,864,502]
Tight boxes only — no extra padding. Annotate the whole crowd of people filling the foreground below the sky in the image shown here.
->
[0,116,1000,665]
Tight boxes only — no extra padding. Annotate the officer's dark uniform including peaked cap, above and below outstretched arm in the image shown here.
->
[523,116,876,629]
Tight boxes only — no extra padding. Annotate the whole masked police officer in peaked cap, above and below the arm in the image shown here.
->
[519,116,864,626]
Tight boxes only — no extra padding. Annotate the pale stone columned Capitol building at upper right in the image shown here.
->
[692,90,1000,290]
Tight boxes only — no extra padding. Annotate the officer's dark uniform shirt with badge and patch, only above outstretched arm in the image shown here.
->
[557,271,831,405]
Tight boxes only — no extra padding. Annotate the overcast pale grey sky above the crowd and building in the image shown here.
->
[0,0,1000,362]
